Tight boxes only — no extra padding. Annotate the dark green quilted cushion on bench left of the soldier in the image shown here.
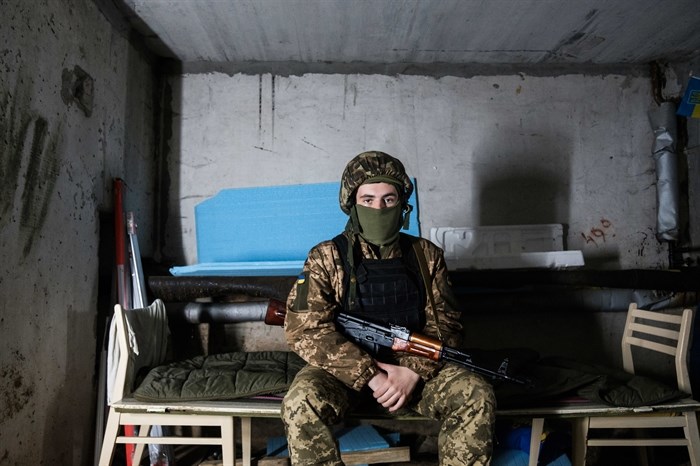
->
[133,351,305,402]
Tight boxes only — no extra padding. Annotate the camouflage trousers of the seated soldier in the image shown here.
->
[282,364,496,466]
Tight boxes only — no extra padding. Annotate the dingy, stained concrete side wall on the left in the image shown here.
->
[0,0,154,466]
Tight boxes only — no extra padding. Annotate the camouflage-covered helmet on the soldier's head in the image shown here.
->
[339,151,413,215]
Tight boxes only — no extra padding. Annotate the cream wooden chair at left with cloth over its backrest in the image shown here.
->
[99,300,236,466]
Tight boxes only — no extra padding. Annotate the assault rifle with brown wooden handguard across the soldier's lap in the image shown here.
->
[265,300,530,385]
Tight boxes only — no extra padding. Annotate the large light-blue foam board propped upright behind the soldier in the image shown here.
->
[170,182,420,276]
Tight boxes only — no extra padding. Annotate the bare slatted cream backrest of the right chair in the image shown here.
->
[622,303,693,395]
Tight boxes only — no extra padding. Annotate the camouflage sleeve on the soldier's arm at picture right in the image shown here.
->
[398,239,462,380]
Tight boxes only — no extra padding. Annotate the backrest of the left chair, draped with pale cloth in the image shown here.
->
[112,299,169,401]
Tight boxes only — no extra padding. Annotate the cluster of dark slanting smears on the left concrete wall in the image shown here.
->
[0,71,62,258]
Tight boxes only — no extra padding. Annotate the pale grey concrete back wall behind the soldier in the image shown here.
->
[164,69,680,269]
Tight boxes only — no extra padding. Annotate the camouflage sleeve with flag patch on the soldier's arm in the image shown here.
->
[284,241,377,390]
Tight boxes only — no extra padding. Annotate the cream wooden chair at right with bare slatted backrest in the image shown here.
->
[573,303,700,466]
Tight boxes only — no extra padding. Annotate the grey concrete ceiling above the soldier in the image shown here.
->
[120,0,700,72]
